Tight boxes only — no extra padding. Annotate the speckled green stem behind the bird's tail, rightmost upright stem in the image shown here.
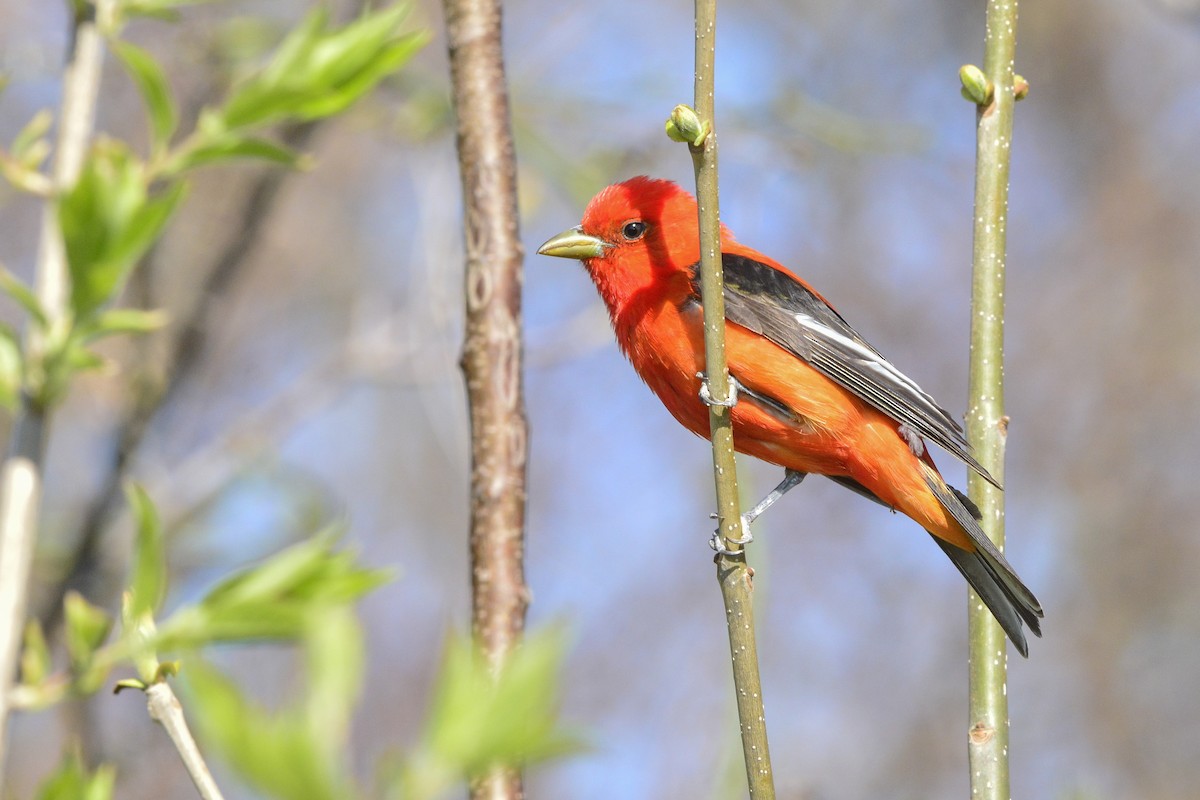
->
[966,0,1016,800]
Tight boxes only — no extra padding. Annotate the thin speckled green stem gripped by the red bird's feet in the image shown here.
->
[691,0,775,800]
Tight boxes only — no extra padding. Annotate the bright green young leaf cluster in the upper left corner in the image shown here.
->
[0,0,428,408]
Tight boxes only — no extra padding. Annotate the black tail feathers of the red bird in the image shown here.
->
[925,473,1043,658]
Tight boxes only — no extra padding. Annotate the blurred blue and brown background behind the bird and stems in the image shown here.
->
[0,0,1200,800]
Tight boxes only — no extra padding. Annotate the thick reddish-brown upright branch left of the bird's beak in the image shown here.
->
[444,0,529,800]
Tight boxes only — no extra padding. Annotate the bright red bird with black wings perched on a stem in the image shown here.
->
[538,176,1043,656]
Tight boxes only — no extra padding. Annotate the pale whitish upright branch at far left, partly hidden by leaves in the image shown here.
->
[0,0,113,786]
